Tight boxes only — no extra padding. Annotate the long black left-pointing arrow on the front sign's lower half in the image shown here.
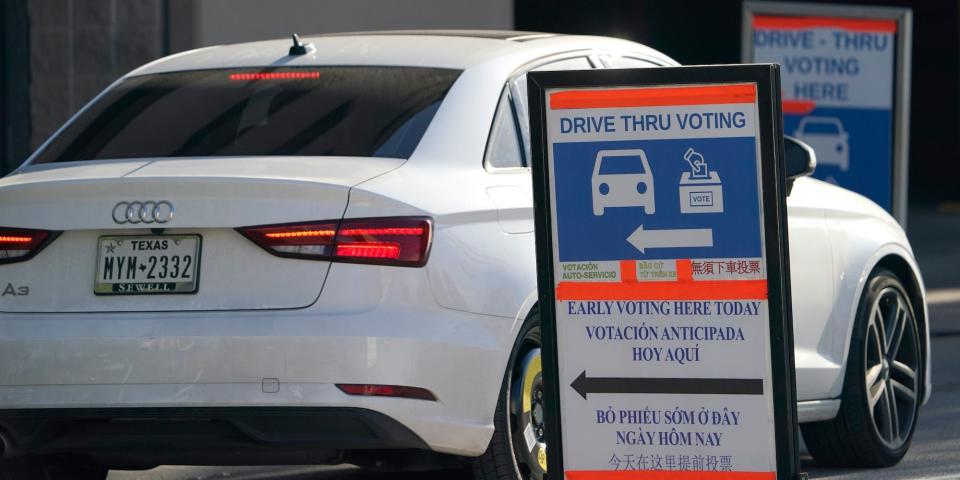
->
[570,371,763,400]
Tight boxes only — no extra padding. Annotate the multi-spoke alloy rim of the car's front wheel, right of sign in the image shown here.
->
[864,287,921,450]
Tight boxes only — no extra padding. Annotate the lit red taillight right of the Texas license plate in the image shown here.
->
[237,217,430,267]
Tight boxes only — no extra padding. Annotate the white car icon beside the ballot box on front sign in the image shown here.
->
[591,149,655,216]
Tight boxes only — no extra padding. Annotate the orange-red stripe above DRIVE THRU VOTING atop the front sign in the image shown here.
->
[550,84,757,110]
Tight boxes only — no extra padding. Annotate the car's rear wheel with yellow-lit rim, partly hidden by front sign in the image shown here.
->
[473,312,547,480]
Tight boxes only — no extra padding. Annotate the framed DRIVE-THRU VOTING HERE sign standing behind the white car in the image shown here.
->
[743,2,910,225]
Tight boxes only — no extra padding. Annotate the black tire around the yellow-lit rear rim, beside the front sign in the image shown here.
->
[473,311,546,480]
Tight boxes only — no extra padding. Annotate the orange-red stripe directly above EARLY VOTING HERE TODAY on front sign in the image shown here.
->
[556,280,767,301]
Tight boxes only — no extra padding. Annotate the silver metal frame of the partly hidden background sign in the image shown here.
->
[740,1,913,229]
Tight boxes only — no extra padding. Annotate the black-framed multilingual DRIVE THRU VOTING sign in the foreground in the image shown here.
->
[528,65,799,480]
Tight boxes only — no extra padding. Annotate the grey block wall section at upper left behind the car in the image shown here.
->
[27,0,165,150]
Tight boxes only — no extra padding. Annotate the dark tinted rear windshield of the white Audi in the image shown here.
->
[33,67,460,163]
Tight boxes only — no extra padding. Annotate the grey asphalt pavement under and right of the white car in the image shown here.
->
[109,211,960,480]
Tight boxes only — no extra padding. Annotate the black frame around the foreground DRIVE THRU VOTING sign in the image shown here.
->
[527,64,805,480]
